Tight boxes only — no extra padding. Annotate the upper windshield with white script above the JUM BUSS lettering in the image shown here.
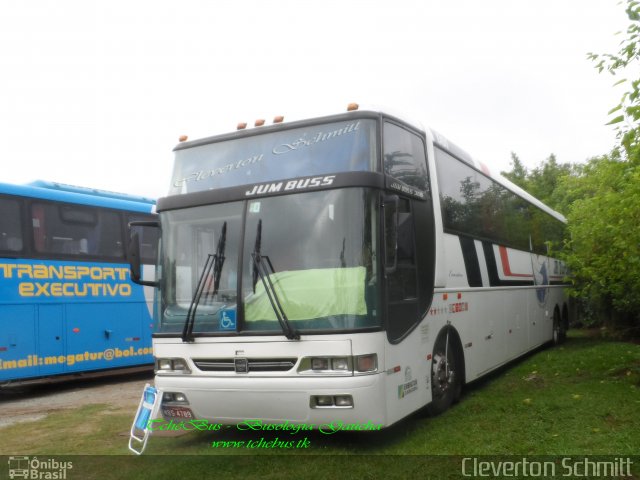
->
[169,119,377,195]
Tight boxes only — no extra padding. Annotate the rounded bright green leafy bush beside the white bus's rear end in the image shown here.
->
[562,156,640,328]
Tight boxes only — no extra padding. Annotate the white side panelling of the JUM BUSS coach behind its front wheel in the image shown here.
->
[436,234,566,382]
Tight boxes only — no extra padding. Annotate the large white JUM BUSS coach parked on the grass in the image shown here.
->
[130,105,570,427]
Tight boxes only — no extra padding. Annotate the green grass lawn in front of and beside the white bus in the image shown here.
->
[0,331,640,480]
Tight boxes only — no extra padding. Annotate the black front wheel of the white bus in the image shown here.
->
[427,332,462,415]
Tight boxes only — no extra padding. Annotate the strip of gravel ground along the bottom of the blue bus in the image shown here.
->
[0,371,153,428]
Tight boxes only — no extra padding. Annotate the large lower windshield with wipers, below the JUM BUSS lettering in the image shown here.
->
[158,188,381,335]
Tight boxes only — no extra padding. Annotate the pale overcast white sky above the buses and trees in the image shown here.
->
[0,0,627,198]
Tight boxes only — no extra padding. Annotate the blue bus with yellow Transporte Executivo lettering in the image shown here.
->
[0,181,157,386]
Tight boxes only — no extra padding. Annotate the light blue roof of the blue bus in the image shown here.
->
[0,180,155,213]
